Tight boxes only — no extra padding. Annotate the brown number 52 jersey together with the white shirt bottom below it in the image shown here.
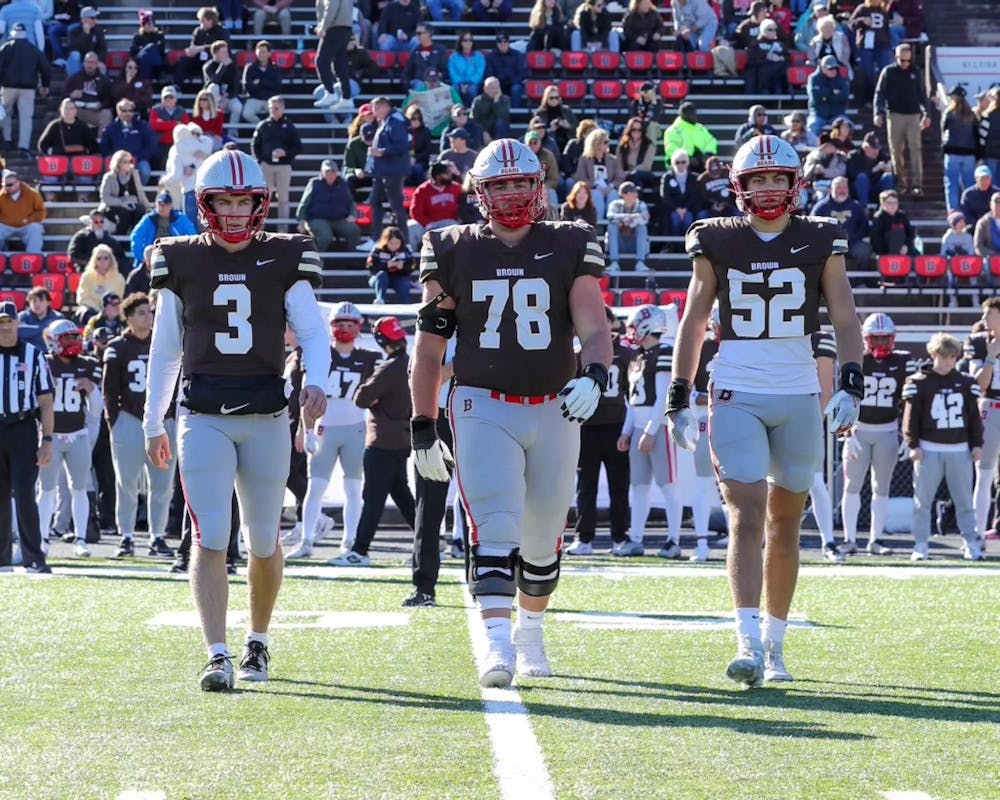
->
[686,216,847,394]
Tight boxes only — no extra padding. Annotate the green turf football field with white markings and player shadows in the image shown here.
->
[0,559,1000,800]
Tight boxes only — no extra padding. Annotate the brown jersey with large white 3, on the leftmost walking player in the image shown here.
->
[150,233,322,377]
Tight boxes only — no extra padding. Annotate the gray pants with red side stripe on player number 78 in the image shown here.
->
[449,386,580,564]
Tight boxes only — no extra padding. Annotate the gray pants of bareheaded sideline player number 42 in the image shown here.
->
[913,450,976,544]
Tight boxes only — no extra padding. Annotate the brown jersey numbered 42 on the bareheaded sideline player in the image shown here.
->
[903,368,983,448]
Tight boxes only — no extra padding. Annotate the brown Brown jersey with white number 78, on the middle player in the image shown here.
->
[420,222,604,395]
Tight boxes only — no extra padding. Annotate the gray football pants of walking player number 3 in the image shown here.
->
[177,409,292,558]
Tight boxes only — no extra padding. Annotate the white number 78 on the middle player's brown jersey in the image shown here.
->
[472,278,552,350]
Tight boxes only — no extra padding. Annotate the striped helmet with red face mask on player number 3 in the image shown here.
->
[194,149,271,244]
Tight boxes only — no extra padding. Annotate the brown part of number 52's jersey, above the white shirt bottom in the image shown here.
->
[686,216,847,340]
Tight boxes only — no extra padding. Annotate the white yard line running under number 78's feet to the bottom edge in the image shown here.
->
[465,590,555,800]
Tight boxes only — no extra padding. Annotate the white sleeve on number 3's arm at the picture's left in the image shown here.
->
[142,289,184,439]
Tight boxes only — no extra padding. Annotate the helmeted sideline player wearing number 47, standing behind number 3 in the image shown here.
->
[286,303,381,558]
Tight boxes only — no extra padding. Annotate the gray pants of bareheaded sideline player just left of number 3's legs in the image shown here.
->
[111,411,177,539]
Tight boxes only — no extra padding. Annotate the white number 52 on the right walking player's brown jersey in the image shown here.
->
[729,267,806,339]
